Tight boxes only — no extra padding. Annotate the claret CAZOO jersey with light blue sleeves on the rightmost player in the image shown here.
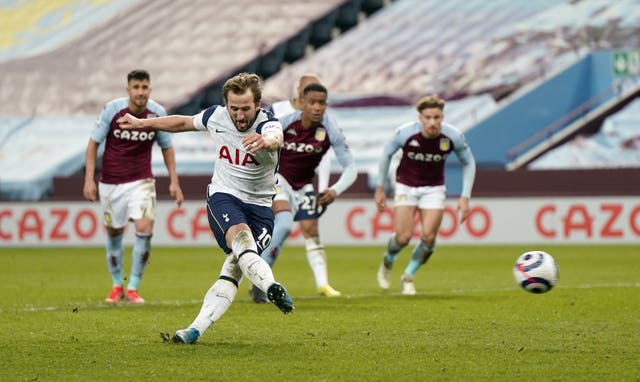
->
[383,122,473,187]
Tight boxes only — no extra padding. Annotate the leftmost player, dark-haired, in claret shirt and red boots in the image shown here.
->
[83,70,184,304]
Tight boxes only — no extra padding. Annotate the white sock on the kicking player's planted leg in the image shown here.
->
[189,279,238,335]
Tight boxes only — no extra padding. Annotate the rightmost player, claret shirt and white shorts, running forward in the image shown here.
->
[375,95,476,295]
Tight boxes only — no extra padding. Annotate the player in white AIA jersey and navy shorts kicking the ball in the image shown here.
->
[119,73,294,343]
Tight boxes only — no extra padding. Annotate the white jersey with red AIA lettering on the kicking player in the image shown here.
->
[193,105,282,207]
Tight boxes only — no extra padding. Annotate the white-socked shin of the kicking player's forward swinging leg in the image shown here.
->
[231,231,275,292]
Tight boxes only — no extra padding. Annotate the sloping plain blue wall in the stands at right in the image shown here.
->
[467,51,635,169]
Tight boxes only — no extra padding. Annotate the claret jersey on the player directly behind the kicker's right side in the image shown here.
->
[278,110,353,190]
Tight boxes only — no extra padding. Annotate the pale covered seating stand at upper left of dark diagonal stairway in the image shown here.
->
[0,0,390,200]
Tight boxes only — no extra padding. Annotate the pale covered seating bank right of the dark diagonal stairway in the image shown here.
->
[265,0,640,100]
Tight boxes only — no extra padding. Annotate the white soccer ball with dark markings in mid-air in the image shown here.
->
[513,251,558,293]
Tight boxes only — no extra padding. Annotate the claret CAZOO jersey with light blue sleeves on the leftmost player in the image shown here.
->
[91,97,172,184]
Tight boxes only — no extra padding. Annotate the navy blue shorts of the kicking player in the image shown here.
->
[207,192,273,253]
